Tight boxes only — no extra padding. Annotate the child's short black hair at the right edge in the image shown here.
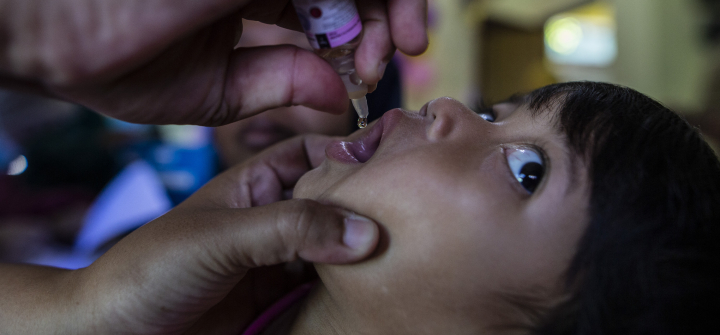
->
[524,82,720,335]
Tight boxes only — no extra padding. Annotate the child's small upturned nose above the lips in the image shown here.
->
[419,97,470,141]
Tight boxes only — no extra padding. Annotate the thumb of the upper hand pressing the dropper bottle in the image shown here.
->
[224,45,348,123]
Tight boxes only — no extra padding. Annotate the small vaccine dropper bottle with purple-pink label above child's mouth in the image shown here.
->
[293,0,369,128]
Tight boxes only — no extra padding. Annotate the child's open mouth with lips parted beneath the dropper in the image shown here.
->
[325,110,402,164]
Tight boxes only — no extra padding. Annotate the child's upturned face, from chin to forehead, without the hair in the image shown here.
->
[295,98,589,328]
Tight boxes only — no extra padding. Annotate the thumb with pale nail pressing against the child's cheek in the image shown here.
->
[229,199,379,268]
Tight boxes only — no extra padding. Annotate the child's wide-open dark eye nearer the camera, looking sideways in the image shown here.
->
[505,148,545,194]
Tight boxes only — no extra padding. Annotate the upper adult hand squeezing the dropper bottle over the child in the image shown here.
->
[0,0,427,126]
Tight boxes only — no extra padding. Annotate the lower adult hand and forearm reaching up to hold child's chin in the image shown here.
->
[0,136,378,334]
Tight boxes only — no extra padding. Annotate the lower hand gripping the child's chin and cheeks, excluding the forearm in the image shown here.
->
[72,136,378,333]
